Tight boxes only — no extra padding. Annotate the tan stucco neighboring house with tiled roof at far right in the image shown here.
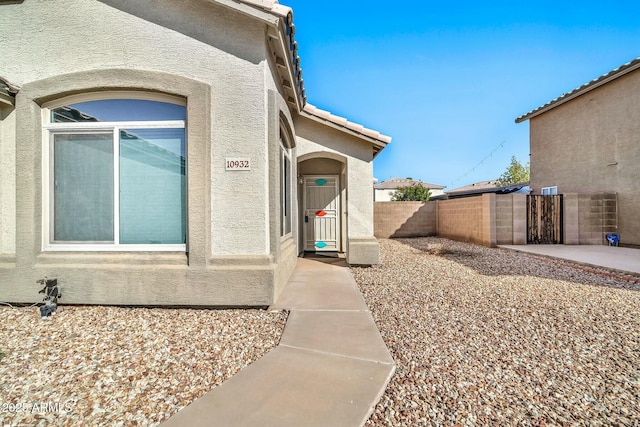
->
[516,58,640,245]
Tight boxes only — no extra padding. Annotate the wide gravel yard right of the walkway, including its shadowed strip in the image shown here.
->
[352,238,640,426]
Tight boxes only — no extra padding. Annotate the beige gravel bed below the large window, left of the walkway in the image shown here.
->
[0,306,286,426]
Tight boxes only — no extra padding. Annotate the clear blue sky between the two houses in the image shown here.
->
[280,0,640,189]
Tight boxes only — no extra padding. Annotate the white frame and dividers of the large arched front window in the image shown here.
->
[42,91,189,252]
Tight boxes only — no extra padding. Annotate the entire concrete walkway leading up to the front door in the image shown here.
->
[163,258,395,427]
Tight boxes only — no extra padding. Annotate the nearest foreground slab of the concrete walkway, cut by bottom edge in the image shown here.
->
[163,347,394,427]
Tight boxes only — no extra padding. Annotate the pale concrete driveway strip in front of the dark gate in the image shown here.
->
[499,245,640,274]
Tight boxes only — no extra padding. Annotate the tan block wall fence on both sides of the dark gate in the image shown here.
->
[374,194,617,247]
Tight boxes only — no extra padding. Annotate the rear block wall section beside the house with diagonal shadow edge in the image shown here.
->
[373,202,437,239]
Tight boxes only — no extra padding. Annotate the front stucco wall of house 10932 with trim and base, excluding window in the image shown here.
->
[0,0,295,305]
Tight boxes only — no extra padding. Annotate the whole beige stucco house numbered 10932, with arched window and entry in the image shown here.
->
[0,0,391,306]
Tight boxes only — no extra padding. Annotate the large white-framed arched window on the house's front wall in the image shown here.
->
[44,92,187,250]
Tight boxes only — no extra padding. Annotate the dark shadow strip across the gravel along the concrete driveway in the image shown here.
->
[393,237,640,291]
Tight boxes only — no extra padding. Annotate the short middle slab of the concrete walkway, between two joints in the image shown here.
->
[280,311,393,364]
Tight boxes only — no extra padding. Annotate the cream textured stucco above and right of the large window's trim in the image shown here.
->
[0,0,276,255]
